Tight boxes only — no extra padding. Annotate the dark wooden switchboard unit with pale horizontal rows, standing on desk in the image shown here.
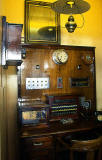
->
[46,95,79,121]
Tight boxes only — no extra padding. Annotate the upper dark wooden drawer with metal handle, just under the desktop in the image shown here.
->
[23,136,53,150]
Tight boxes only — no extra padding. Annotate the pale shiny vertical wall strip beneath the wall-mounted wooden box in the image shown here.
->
[7,66,18,160]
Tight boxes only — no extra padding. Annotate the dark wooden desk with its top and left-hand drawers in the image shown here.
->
[20,119,102,160]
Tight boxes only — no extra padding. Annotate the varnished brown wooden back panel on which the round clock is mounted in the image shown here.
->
[20,46,95,110]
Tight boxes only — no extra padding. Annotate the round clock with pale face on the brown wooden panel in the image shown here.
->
[52,49,68,64]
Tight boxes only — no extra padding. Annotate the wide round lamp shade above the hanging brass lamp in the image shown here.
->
[51,0,90,14]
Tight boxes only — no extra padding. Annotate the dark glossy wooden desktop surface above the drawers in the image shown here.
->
[21,120,102,138]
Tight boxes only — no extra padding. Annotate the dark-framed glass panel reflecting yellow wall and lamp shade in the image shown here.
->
[25,1,60,43]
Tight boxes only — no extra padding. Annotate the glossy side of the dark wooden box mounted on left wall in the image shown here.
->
[6,23,22,65]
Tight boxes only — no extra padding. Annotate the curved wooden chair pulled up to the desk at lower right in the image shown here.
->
[56,133,102,160]
